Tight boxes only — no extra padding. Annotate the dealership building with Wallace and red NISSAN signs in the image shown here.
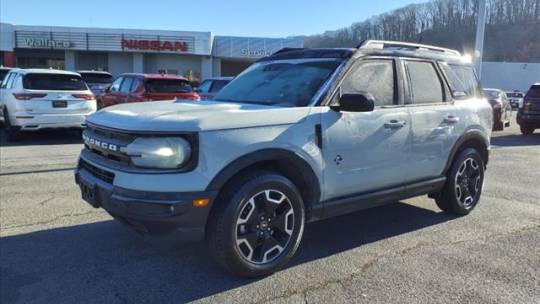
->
[0,23,303,80]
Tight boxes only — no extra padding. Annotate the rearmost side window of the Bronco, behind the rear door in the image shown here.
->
[440,63,480,97]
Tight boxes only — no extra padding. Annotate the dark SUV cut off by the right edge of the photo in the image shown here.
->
[517,83,540,135]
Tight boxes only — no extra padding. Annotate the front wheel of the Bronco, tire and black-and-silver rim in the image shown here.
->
[207,171,305,277]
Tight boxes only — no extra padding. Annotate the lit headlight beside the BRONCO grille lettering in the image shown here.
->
[121,137,191,169]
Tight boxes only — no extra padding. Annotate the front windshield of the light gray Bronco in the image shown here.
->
[214,59,341,107]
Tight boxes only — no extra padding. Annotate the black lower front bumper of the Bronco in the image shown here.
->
[75,160,217,241]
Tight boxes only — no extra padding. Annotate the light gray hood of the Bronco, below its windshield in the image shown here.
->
[87,100,309,132]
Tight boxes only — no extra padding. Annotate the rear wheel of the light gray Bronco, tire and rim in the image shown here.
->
[435,148,485,215]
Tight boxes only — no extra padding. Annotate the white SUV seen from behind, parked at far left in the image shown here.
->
[0,69,96,140]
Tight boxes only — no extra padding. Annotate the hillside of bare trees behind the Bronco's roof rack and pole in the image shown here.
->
[303,0,540,62]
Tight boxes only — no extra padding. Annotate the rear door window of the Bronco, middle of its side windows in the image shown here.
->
[405,61,444,104]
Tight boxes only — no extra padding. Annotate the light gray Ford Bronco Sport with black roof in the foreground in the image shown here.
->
[75,41,492,277]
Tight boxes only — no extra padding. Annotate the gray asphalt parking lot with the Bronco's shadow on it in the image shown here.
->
[0,122,540,303]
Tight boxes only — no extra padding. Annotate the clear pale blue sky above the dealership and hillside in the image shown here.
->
[0,0,425,37]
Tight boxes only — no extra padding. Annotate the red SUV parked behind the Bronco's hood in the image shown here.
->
[98,74,200,108]
